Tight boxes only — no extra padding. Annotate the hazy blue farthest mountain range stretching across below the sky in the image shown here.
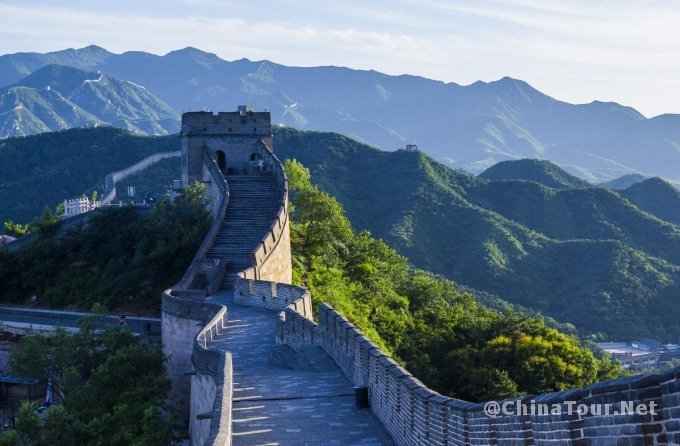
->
[0,46,680,182]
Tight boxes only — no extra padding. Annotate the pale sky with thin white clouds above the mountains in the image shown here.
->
[0,0,680,117]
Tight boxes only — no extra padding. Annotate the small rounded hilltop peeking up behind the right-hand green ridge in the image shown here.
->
[479,159,592,189]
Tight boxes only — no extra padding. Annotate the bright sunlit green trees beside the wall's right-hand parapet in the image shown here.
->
[286,160,620,401]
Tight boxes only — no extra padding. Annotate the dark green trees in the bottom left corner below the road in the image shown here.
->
[0,320,179,446]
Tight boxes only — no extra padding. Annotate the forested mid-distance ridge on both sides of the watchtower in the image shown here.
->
[0,128,680,342]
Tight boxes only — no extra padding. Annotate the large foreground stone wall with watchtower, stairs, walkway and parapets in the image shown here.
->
[162,107,680,446]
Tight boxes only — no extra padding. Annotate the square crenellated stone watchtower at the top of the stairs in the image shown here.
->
[181,105,272,187]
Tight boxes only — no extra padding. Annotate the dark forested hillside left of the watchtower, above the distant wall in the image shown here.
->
[0,128,178,223]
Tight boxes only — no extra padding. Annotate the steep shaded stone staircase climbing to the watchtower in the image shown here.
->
[207,172,281,290]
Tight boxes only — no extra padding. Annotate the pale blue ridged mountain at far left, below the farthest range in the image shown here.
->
[0,65,179,137]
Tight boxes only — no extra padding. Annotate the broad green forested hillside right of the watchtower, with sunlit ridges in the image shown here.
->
[274,129,680,340]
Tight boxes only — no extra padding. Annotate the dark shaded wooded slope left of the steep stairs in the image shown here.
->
[0,183,210,314]
